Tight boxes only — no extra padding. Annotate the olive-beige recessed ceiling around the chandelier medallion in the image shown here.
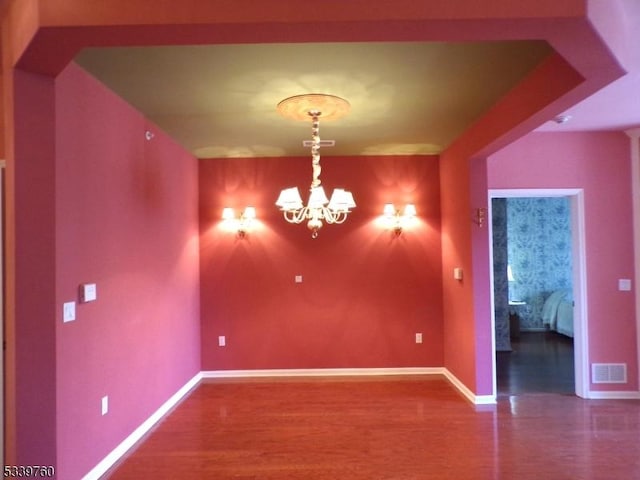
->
[76,41,551,158]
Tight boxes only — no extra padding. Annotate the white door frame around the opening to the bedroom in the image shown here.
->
[487,188,589,398]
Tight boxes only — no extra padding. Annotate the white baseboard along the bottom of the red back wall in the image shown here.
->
[201,367,445,378]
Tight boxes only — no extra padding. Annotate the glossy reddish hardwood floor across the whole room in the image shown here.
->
[103,366,640,480]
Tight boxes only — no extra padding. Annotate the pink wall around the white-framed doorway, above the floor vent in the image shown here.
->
[488,132,638,391]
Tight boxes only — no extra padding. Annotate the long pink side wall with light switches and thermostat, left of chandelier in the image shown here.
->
[49,64,200,479]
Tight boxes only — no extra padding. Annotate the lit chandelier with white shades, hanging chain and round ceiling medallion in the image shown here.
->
[276,93,356,238]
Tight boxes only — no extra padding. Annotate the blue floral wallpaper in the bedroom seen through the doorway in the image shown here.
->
[492,197,572,350]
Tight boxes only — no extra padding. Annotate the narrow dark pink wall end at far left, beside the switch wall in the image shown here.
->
[12,67,59,472]
